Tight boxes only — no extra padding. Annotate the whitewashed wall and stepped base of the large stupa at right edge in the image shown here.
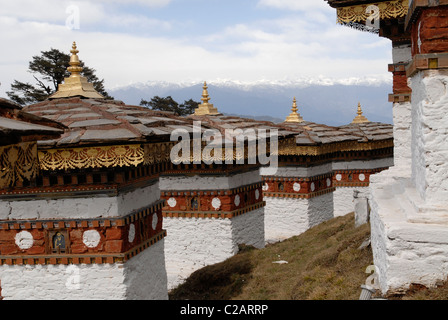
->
[369,71,448,293]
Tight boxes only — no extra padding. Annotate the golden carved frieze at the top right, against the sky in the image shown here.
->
[337,0,409,24]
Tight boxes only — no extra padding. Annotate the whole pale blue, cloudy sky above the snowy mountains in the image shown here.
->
[0,0,391,96]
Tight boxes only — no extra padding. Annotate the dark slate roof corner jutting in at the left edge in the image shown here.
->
[0,98,65,145]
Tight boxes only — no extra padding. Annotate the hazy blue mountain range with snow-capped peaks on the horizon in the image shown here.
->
[108,78,392,125]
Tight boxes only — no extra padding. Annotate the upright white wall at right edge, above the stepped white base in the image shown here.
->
[411,71,448,204]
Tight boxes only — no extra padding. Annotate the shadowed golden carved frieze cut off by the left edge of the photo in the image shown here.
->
[0,142,39,188]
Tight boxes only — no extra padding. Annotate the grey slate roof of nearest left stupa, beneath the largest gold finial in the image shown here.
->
[25,97,205,148]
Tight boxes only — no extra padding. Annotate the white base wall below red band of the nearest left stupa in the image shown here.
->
[0,240,168,300]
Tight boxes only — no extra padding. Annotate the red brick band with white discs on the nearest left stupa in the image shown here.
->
[0,200,166,264]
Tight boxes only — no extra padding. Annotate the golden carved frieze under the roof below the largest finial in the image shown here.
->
[38,142,174,170]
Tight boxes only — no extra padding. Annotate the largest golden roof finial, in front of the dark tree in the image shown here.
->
[49,42,104,99]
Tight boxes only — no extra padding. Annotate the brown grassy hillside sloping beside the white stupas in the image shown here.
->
[170,214,448,300]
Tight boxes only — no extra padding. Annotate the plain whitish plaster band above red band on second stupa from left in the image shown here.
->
[160,169,261,191]
